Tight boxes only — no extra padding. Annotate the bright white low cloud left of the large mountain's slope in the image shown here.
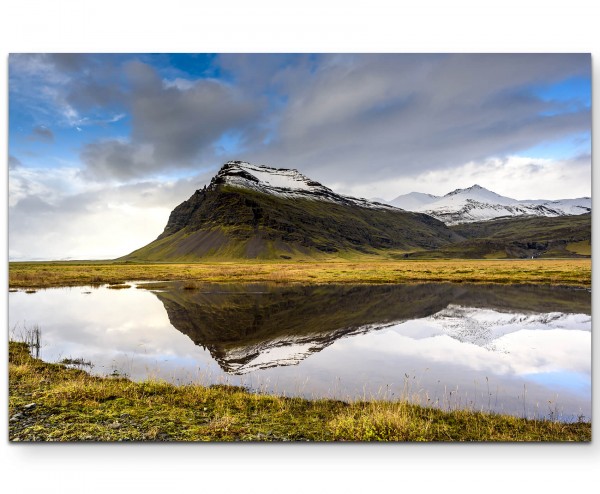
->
[8,167,207,260]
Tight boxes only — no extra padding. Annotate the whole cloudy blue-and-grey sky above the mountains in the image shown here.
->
[8,53,592,260]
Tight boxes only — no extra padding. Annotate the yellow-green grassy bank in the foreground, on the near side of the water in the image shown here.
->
[9,342,591,441]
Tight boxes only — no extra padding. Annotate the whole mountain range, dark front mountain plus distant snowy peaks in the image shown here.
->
[121,161,591,261]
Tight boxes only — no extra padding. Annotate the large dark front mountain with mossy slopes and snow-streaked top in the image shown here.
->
[121,161,462,261]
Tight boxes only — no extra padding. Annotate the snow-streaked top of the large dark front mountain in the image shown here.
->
[209,161,392,209]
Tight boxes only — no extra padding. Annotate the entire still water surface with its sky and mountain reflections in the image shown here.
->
[9,282,591,421]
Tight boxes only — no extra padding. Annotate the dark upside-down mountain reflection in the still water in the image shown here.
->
[146,283,591,374]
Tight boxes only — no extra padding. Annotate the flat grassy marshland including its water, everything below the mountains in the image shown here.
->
[9,259,591,441]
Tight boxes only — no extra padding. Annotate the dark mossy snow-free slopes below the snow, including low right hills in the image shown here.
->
[119,184,591,262]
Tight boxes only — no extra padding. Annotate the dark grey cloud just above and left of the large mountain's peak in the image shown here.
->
[81,62,262,178]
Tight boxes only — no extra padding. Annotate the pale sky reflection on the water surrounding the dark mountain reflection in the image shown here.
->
[9,287,591,420]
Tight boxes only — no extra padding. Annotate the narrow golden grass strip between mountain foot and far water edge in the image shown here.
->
[9,259,592,288]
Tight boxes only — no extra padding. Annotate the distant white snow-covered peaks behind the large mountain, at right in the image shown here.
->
[390,185,592,225]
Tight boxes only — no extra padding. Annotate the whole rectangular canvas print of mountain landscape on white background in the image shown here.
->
[8,53,592,442]
